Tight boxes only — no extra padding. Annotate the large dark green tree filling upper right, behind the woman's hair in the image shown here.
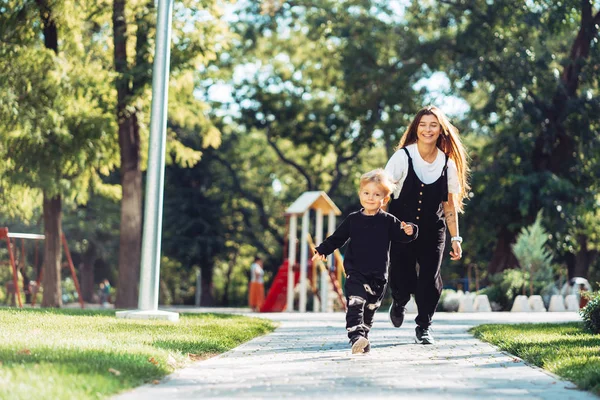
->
[422,0,600,273]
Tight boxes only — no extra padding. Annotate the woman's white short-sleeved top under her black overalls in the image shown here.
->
[385,143,460,199]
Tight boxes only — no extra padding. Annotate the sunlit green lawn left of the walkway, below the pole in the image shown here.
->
[0,309,274,400]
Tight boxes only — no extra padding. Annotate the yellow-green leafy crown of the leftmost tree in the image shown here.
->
[0,6,118,204]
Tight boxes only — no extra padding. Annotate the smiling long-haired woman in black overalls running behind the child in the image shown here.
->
[385,106,469,344]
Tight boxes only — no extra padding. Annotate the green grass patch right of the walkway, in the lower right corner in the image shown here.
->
[471,323,600,394]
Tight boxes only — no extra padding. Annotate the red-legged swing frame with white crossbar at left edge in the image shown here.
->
[0,227,84,308]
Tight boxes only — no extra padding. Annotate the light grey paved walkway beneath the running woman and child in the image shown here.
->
[115,312,598,400]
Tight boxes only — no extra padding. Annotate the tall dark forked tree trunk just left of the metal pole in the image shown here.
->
[112,0,154,308]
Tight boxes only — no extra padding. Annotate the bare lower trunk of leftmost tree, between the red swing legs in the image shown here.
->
[42,192,62,307]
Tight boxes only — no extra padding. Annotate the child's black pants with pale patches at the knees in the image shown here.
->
[344,272,387,339]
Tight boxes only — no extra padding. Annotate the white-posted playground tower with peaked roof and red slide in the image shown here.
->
[260,191,346,312]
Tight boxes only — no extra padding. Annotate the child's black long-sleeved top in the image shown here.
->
[316,210,418,279]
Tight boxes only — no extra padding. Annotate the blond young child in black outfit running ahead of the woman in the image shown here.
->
[312,169,418,354]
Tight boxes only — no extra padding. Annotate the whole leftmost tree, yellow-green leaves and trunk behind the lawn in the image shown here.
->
[0,0,114,307]
